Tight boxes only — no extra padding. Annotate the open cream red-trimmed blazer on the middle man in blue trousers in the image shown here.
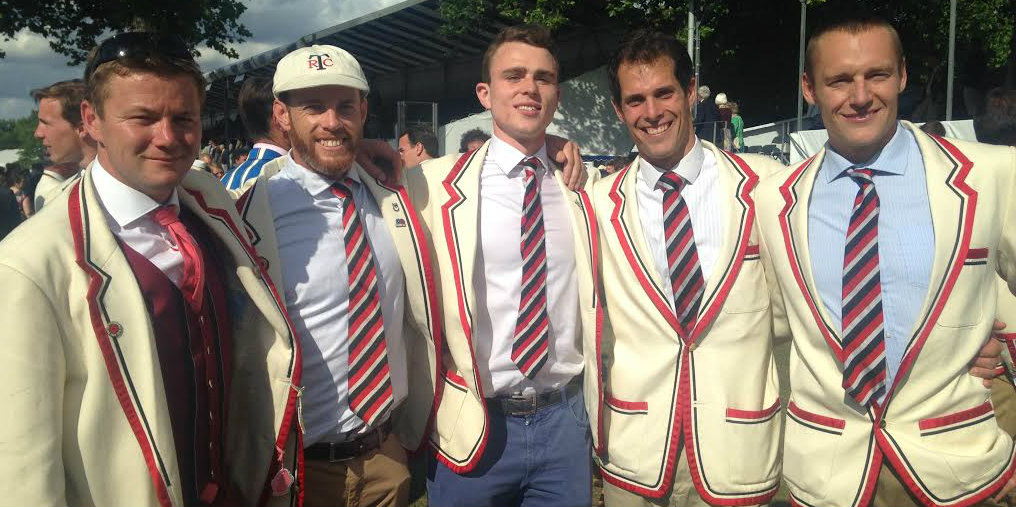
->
[406,142,602,473]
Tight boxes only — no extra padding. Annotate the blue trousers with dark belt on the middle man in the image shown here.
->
[427,391,592,507]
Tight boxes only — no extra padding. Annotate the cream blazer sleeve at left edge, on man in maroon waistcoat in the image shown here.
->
[0,264,67,506]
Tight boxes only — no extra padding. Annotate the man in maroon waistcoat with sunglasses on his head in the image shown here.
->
[0,34,300,507]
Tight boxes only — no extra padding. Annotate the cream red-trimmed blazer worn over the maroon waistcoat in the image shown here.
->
[0,171,300,507]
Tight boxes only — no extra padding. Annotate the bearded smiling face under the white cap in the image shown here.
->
[275,85,367,180]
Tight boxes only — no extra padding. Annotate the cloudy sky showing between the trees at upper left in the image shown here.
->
[0,0,417,118]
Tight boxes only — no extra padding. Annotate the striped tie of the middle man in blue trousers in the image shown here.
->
[511,156,551,379]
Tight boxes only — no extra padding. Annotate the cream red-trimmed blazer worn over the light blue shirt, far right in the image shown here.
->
[757,122,1016,507]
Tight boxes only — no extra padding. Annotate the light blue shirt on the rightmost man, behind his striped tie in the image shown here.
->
[808,123,935,392]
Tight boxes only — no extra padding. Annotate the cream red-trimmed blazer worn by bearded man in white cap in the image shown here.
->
[237,155,442,450]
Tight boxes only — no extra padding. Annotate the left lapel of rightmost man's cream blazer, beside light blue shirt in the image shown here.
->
[779,148,844,353]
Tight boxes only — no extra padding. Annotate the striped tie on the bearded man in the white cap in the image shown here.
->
[331,178,392,427]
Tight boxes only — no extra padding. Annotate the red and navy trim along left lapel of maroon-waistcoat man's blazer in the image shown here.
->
[67,180,175,507]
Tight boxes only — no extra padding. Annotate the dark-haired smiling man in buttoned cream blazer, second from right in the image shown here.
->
[592,31,783,507]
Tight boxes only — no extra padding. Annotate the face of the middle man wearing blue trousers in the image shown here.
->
[477,42,561,154]
